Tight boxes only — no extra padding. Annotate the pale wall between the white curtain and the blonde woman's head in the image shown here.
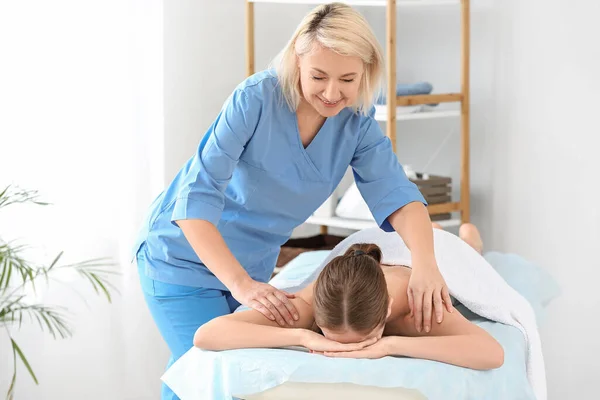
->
[164,0,310,181]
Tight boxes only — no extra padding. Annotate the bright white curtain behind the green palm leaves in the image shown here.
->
[0,0,168,400]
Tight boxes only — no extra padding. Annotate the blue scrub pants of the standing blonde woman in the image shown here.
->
[137,246,240,400]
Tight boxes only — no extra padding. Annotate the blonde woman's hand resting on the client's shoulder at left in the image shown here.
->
[231,279,298,326]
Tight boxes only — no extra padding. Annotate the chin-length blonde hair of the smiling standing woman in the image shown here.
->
[274,3,383,114]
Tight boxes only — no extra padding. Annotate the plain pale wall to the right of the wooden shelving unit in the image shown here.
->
[487,1,600,399]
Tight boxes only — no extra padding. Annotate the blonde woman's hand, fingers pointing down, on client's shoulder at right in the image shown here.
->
[407,262,453,333]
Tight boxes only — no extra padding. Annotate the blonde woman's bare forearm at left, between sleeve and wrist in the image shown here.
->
[176,219,251,290]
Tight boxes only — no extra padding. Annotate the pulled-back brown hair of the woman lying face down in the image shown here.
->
[314,243,389,333]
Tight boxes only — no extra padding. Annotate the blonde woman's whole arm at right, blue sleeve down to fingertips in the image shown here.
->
[351,108,452,329]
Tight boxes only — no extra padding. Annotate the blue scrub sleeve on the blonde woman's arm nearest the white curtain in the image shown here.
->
[171,88,261,225]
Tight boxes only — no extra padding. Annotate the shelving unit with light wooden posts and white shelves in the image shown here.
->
[246,0,470,233]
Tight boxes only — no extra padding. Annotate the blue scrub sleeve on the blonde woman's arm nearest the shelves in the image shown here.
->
[351,109,427,232]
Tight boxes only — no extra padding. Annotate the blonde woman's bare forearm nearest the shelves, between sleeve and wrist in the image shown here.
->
[388,202,435,265]
